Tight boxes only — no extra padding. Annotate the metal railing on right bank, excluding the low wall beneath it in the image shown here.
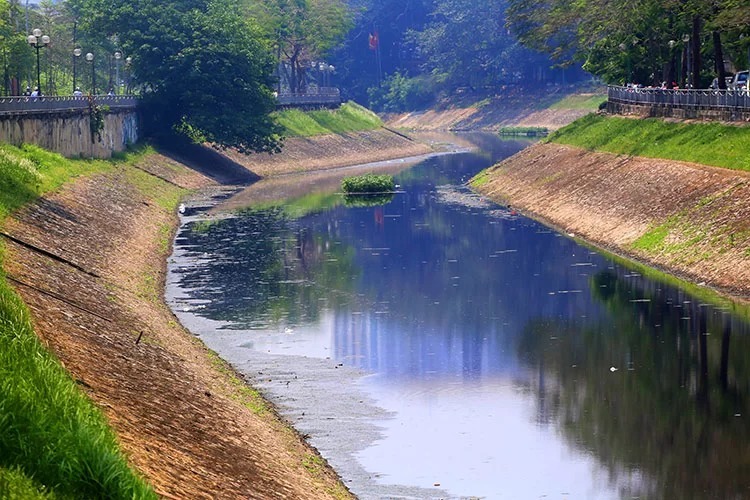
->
[607,86,750,110]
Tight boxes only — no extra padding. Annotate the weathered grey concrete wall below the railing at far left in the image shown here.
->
[0,109,139,158]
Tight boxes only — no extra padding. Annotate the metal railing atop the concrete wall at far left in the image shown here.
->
[0,95,139,115]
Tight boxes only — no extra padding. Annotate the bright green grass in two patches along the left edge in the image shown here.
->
[0,145,156,498]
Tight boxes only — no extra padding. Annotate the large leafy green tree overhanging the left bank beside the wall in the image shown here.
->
[71,0,280,152]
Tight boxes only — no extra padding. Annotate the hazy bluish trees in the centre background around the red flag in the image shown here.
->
[328,0,582,111]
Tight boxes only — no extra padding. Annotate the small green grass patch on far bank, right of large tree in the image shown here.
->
[274,101,383,137]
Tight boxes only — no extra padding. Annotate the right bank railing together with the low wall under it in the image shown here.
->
[607,86,750,121]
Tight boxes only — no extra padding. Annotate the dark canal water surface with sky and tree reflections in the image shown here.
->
[171,137,750,499]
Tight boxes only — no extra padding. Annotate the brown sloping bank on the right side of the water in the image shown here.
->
[473,144,750,299]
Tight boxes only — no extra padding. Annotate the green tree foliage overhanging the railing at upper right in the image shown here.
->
[508,0,750,88]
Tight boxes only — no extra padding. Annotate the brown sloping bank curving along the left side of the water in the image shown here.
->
[4,131,430,499]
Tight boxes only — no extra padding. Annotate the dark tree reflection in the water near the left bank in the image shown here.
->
[176,207,356,329]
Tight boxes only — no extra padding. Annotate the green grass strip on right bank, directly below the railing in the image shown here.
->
[547,114,750,171]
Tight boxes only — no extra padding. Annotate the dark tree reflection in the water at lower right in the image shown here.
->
[519,269,750,499]
